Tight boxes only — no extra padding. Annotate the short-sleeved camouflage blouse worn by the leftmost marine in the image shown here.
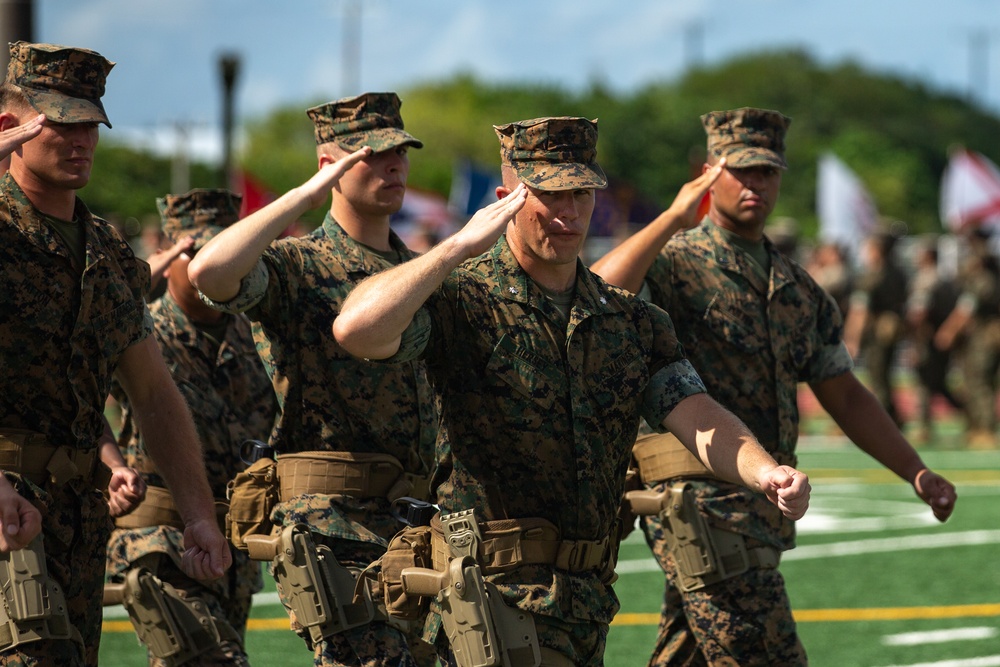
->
[0,174,152,449]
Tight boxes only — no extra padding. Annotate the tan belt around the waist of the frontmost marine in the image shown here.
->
[431,515,616,574]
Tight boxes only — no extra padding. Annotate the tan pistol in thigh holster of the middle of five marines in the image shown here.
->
[247,524,375,644]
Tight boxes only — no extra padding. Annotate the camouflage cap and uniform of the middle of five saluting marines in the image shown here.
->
[202,94,437,665]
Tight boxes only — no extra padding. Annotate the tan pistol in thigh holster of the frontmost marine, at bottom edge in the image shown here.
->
[402,556,541,667]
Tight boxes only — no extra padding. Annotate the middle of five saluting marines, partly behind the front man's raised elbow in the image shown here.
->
[192,93,437,665]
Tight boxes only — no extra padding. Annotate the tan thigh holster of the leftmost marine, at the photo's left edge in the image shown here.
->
[0,535,72,651]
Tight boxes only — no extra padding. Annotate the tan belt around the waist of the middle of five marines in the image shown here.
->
[278,452,406,500]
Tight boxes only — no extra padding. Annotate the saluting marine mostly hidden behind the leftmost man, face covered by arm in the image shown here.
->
[107,190,277,666]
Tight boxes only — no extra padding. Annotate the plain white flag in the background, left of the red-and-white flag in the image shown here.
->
[816,153,878,257]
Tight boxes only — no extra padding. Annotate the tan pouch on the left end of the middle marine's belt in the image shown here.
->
[226,458,278,551]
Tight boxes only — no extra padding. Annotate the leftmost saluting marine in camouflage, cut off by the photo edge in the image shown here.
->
[0,42,225,666]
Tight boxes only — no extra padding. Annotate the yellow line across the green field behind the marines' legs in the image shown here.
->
[103,604,1000,632]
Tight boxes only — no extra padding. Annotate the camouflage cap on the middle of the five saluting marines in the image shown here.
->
[306,93,424,153]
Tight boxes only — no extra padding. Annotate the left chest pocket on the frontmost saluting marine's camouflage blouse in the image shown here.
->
[486,335,564,430]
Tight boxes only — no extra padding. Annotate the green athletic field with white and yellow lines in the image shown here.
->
[101,430,1000,667]
